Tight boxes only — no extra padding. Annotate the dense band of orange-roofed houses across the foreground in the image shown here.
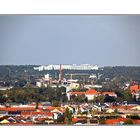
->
[0,103,140,125]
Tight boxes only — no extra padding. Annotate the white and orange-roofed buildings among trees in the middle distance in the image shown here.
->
[36,74,106,101]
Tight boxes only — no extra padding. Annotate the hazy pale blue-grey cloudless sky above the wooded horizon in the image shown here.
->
[0,15,140,66]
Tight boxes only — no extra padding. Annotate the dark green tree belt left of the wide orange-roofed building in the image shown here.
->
[0,87,67,106]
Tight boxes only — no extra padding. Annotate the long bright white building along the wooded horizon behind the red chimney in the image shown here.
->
[34,64,98,71]
